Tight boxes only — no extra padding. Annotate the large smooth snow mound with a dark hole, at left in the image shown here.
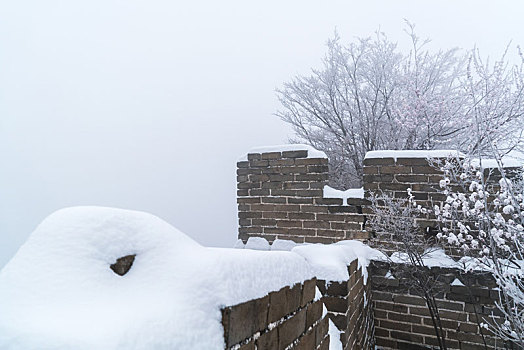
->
[0,207,313,350]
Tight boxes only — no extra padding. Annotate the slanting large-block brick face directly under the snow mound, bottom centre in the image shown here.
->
[222,279,329,350]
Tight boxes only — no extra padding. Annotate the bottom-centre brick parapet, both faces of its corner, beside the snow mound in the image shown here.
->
[222,260,375,350]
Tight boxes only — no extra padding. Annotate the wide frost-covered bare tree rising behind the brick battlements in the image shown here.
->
[276,23,524,189]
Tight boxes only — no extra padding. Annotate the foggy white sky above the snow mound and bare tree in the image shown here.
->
[0,0,524,267]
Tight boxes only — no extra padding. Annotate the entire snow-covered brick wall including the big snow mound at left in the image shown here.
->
[0,145,522,350]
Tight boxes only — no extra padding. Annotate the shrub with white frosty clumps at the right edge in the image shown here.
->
[431,157,524,348]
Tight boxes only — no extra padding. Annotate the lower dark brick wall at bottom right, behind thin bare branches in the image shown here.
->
[369,262,504,350]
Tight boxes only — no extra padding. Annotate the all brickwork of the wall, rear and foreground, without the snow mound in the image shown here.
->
[223,146,520,350]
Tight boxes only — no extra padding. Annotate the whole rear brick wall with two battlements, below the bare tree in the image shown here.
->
[237,146,518,250]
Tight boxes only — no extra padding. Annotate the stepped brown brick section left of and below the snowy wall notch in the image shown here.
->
[237,150,369,243]
